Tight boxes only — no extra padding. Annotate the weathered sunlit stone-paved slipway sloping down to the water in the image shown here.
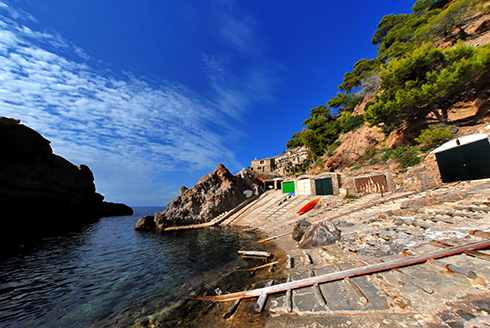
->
[223,180,490,327]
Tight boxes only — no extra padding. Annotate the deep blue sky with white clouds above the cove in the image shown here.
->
[0,0,415,206]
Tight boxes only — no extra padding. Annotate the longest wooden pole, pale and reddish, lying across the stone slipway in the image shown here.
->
[197,239,490,302]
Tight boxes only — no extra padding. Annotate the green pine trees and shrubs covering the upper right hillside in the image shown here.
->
[286,0,490,166]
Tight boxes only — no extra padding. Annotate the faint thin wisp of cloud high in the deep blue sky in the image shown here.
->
[202,1,278,119]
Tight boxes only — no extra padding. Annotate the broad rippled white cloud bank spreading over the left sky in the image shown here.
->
[0,2,247,205]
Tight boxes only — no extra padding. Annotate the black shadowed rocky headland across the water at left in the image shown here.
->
[0,117,133,231]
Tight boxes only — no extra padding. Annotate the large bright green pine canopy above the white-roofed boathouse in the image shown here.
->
[366,44,490,132]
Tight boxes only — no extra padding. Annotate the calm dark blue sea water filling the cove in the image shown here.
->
[0,208,264,327]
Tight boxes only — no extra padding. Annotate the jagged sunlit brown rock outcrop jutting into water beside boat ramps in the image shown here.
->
[136,164,264,230]
